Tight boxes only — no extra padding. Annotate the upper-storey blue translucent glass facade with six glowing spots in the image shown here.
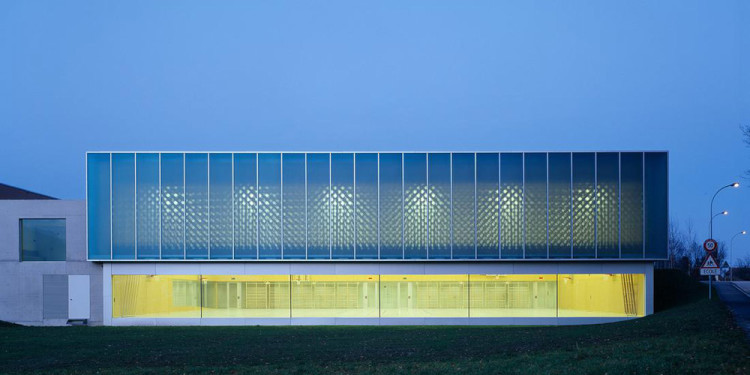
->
[87,152,668,261]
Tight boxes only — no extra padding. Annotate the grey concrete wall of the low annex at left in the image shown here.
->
[0,200,103,325]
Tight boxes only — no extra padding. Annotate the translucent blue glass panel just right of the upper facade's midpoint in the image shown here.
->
[380,154,404,259]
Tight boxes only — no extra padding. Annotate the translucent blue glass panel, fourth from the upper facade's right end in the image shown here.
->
[572,153,596,258]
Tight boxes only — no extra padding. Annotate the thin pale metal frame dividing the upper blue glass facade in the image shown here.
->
[85,151,669,262]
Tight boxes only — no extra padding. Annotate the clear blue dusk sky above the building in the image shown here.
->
[0,0,750,257]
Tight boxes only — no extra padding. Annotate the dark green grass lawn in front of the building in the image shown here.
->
[0,272,750,374]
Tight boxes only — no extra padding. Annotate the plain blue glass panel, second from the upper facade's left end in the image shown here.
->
[112,154,135,259]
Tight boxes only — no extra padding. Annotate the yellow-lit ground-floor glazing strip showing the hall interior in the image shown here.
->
[112,274,645,318]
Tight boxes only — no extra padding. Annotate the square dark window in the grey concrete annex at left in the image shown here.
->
[19,219,65,262]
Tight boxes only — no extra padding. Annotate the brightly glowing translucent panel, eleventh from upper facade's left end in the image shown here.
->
[331,154,354,259]
